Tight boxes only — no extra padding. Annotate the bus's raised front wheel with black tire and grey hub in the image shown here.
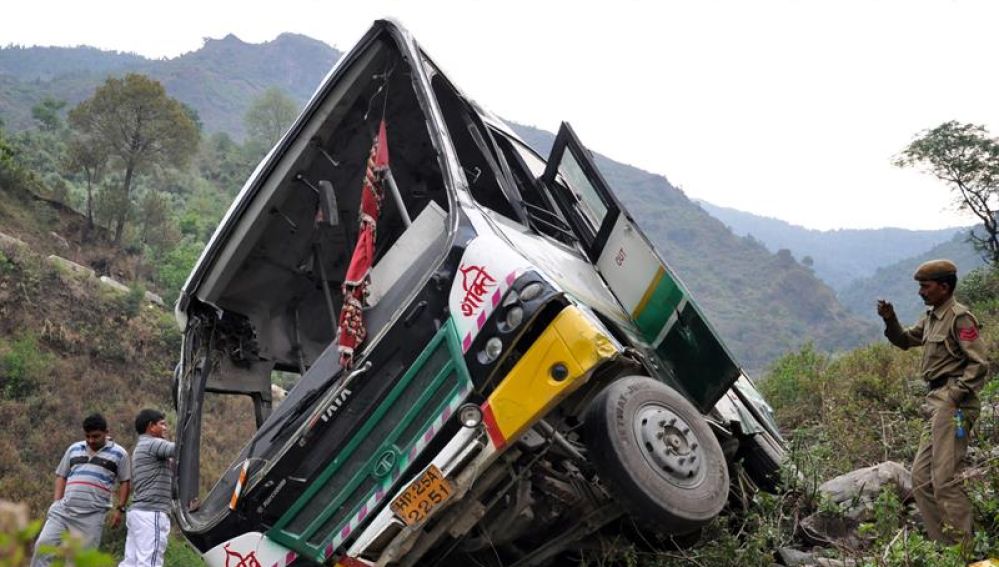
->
[584,376,729,534]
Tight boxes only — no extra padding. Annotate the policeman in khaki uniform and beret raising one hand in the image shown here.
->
[878,260,988,543]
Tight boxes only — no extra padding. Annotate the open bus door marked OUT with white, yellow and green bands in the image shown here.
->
[541,123,740,412]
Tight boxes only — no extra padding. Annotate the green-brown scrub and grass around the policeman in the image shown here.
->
[605,271,999,567]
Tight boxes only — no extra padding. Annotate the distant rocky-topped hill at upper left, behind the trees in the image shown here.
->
[0,33,341,138]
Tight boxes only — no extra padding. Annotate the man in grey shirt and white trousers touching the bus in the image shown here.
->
[118,409,174,567]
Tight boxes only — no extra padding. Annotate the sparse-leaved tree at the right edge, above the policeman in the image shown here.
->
[895,120,999,267]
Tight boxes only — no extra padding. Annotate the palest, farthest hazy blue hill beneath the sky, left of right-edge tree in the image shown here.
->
[697,201,967,292]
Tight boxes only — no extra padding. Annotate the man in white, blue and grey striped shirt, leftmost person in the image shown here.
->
[31,413,132,567]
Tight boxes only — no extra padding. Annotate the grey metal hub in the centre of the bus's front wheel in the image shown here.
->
[634,404,704,487]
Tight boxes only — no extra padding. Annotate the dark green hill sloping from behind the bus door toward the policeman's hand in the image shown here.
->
[514,125,876,371]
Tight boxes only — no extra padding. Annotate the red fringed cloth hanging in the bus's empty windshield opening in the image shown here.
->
[336,120,389,368]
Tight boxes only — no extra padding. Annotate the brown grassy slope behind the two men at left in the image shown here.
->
[0,190,252,567]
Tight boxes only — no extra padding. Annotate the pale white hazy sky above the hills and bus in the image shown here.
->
[0,0,999,229]
